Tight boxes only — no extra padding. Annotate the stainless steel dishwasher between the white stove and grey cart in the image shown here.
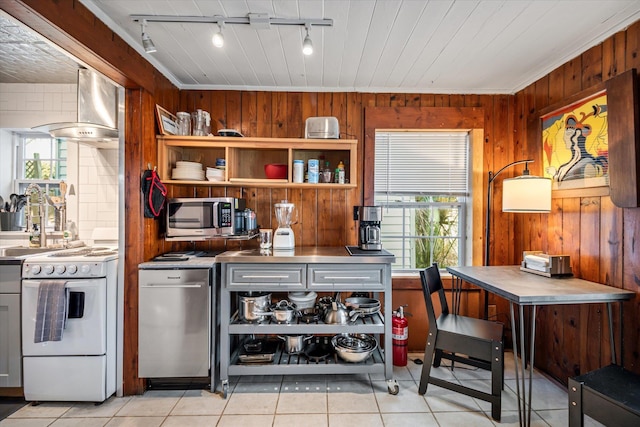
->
[138,262,215,378]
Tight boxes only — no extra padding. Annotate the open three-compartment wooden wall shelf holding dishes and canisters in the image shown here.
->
[157,135,358,189]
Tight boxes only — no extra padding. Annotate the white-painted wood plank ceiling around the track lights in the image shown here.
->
[0,0,640,94]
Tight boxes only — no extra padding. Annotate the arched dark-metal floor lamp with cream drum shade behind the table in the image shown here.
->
[484,159,551,268]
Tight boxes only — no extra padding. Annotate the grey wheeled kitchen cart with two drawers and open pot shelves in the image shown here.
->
[212,247,399,397]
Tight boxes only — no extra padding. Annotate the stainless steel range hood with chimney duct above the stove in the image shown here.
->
[33,68,119,148]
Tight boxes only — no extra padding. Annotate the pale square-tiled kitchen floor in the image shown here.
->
[0,353,599,427]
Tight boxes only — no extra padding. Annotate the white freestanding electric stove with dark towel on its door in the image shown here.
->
[22,247,118,402]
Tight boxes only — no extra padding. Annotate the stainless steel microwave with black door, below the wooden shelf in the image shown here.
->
[166,197,246,240]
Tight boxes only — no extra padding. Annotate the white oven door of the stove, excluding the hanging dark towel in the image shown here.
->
[22,278,107,356]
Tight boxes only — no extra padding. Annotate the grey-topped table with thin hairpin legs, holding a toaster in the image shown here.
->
[447,265,635,426]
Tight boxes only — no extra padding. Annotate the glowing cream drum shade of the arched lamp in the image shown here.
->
[502,175,551,213]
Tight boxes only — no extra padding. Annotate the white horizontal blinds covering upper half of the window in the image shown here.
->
[374,132,469,196]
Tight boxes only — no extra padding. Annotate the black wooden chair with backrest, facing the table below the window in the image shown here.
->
[418,263,504,421]
